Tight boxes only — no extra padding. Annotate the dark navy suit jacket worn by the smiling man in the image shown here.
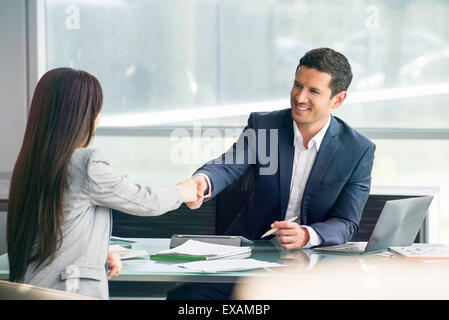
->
[196,109,376,246]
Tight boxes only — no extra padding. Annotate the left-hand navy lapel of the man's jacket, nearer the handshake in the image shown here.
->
[278,111,295,219]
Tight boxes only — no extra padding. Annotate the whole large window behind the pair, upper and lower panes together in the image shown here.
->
[40,0,449,239]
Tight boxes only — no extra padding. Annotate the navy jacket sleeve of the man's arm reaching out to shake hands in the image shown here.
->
[194,113,257,197]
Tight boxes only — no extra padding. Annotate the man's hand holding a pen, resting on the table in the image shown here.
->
[271,221,310,249]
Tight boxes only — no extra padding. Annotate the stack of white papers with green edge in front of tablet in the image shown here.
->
[150,240,251,260]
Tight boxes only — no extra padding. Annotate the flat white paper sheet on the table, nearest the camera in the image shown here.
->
[177,259,285,272]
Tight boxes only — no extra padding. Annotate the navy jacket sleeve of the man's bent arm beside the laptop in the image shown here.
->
[311,144,376,246]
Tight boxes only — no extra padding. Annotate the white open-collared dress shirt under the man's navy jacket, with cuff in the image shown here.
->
[285,116,331,248]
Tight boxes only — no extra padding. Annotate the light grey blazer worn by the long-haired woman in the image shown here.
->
[24,148,182,299]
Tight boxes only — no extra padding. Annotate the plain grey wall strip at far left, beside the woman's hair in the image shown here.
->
[0,0,27,172]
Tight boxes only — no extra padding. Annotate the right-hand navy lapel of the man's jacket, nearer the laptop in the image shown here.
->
[301,117,339,224]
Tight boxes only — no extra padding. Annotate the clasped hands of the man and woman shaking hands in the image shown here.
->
[176,174,209,210]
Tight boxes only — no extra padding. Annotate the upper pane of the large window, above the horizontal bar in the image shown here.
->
[46,0,449,125]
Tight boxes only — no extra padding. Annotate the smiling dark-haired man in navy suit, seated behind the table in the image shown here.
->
[169,48,375,299]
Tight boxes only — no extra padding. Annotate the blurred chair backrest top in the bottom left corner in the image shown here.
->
[0,280,98,300]
